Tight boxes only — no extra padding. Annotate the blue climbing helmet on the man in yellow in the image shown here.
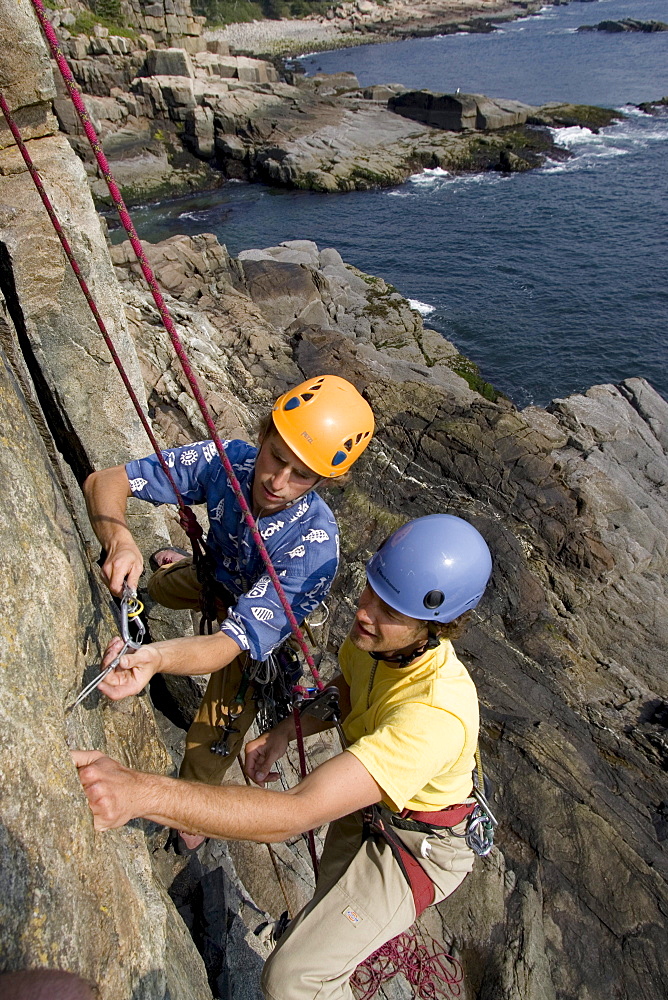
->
[366,514,492,622]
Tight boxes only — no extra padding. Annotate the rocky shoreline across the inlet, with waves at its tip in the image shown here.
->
[44,0,620,204]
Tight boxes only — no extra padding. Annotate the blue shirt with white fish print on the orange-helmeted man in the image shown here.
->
[125,441,339,660]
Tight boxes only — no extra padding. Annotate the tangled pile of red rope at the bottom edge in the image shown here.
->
[350,933,464,1000]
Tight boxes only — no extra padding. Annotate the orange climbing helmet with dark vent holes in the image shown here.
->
[271,375,374,479]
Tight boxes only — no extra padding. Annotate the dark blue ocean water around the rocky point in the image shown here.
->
[112,0,668,406]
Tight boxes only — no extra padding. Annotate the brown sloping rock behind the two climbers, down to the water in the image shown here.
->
[107,230,668,1000]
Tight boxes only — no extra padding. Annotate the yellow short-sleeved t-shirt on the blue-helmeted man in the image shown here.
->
[339,639,479,812]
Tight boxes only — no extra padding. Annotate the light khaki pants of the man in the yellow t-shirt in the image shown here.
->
[262,812,474,1000]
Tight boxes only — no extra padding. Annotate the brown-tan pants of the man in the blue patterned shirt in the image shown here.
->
[147,558,255,785]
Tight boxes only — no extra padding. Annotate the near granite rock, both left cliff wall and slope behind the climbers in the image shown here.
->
[0,0,668,1000]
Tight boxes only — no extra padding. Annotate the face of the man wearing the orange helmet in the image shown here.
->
[252,430,320,517]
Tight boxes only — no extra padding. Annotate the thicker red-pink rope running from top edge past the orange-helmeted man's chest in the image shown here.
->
[31,0,324,691]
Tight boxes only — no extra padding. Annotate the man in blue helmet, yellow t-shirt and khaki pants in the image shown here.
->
[74,514,492,1000]
